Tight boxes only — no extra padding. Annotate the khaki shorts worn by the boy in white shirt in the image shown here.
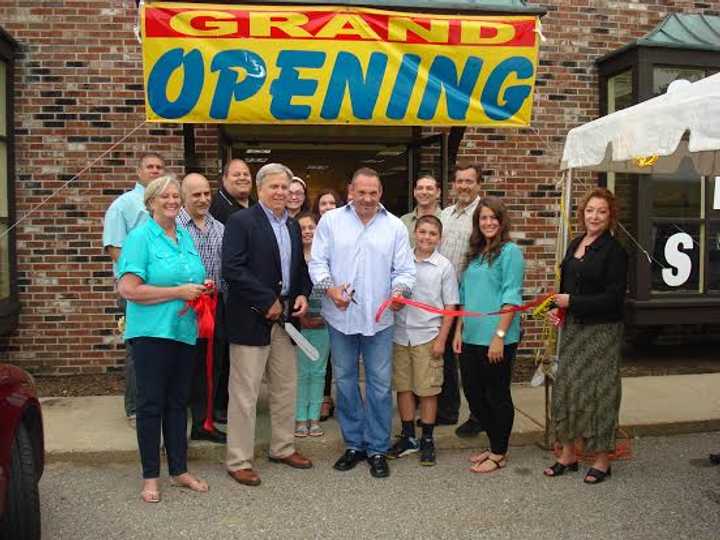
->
[393,340,443,397]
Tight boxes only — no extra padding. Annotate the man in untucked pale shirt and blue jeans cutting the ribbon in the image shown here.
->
[309,168,415,478]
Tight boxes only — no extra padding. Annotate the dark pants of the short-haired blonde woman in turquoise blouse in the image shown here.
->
[132,337,195,478]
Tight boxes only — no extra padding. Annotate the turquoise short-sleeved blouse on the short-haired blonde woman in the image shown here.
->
[118,219,205,345]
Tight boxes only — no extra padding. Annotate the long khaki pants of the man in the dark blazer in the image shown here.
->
[226,324,297,471]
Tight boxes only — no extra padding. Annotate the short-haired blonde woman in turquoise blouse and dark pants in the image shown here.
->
[118,176,211,503]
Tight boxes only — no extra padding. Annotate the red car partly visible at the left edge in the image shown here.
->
[0,363,45,540]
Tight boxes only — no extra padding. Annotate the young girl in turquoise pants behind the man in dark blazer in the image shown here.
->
[295,212,330,437]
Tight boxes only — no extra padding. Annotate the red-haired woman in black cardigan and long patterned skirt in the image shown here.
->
[544,188,627,484]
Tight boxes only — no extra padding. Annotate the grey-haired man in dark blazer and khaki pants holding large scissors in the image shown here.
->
[222,163,312,486]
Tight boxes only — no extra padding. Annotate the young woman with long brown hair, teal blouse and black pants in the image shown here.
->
[453,197,525,473]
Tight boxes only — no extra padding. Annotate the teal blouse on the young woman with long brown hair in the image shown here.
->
[460,242,525,347]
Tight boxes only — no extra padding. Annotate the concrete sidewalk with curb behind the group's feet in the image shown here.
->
[42,373,720,463]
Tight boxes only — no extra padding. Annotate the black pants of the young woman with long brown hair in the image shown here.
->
[460,343,517,454]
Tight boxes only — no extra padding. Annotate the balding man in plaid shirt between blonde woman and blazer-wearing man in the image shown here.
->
[177,173,227,444]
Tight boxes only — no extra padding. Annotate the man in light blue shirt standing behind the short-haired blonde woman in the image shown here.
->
[103,152,165,424]
